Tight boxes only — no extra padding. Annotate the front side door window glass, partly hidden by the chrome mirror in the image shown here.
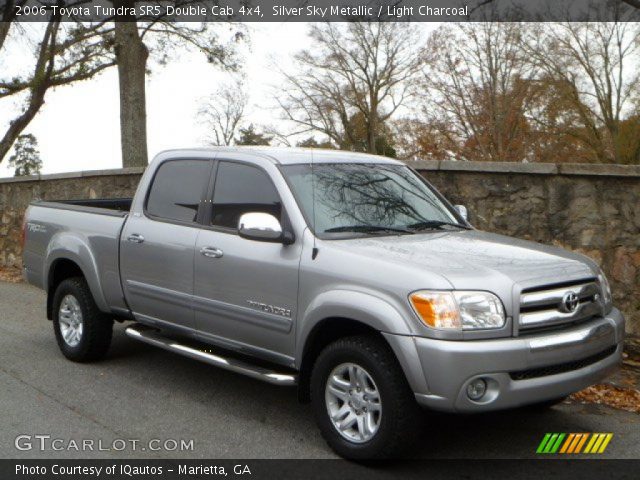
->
[211,162,282,229]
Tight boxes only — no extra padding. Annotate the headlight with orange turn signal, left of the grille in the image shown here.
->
[409,290,505,330]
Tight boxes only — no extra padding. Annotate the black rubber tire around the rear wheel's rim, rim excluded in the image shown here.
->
[53,277,113,362]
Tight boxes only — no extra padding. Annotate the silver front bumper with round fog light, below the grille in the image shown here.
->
[387,309,624,412]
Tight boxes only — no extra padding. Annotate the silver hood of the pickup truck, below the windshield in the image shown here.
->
[339,230,596,291]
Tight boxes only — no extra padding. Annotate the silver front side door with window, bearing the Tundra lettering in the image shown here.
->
[194,160,300,363]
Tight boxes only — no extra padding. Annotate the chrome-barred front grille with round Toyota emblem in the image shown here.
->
[518,278,602,333]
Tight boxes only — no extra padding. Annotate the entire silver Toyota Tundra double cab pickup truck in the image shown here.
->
[24,148,624,459]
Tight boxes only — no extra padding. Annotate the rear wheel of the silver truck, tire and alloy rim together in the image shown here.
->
[53,277,113,362]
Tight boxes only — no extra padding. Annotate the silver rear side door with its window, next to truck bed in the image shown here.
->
[120,159,213,332]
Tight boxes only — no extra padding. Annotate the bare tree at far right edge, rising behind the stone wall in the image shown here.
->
[523,18,640,163]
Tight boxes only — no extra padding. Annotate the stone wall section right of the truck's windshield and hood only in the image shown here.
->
[414,162,640,333]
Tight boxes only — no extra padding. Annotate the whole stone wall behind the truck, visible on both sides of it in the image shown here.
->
[0,161,640,333]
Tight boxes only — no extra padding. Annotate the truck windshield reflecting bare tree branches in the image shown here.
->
[282,163,468,238]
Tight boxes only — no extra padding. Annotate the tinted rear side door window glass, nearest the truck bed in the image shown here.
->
[147,160,210,222]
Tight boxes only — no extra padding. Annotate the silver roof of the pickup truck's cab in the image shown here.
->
[156,146,402,165]
